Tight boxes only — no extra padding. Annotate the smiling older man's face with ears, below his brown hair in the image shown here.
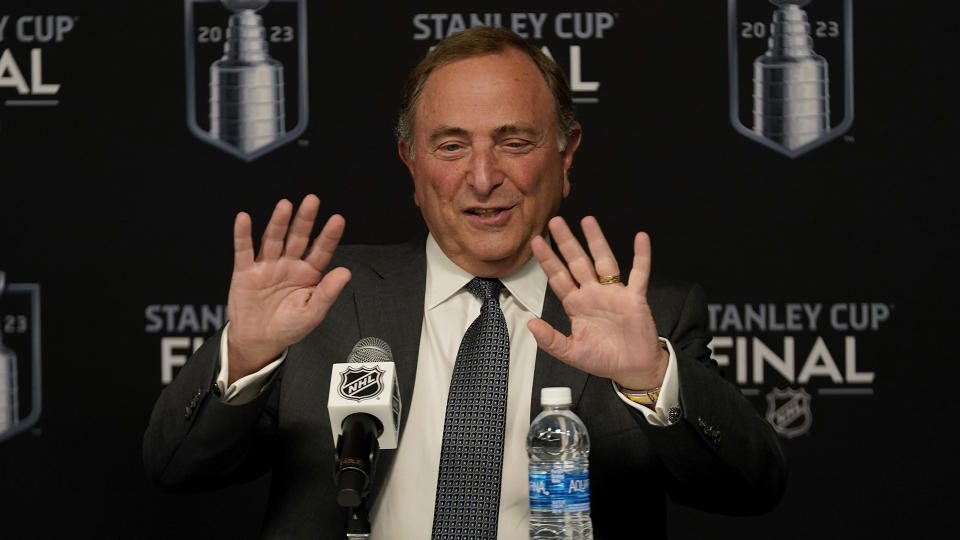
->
[400,49,580,277]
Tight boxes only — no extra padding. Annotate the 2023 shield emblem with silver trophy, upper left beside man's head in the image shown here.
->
[184,0,307,161]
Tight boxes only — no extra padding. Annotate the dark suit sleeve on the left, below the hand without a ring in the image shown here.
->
[143,333,283,491]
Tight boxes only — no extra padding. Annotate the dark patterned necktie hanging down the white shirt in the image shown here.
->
[433,278,510,540]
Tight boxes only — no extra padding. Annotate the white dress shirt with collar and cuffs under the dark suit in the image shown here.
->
[217,235,679,540]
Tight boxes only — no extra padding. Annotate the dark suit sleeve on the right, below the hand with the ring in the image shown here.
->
[638,286,787,514]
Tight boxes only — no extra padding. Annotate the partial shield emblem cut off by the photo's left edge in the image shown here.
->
[0,271,40,442]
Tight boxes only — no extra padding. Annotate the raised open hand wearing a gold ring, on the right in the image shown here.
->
[527,216,669,390]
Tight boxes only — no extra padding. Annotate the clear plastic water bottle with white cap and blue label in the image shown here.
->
[527,387,593,540]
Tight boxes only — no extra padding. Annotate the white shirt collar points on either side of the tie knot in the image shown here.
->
[424,234,547,317]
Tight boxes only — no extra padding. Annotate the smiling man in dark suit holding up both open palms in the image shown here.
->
[144,29,785,538]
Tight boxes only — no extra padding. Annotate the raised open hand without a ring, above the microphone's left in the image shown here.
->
[227,195,350,384]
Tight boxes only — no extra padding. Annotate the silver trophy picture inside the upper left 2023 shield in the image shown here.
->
[210,0,285,153]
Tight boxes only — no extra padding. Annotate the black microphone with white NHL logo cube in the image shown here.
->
[327,337,400,508]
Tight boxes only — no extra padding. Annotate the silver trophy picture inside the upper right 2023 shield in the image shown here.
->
[753,0,830,150]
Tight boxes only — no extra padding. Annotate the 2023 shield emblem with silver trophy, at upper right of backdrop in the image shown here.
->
[727,0,853,158]
